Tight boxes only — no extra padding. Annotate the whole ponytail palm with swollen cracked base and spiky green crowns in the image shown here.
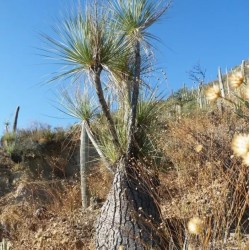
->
[43,0,173,250]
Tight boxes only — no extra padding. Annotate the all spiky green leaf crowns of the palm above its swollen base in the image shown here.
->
[43,0,171,166]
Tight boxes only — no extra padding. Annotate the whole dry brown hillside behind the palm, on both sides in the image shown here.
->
[0,62,249,250]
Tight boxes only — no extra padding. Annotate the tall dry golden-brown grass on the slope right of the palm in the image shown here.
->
[160,108,249,249]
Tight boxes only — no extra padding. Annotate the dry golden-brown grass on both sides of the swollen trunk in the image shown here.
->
[0,99,249,250]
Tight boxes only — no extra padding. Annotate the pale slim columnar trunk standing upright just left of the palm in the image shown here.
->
[80,121,88,209]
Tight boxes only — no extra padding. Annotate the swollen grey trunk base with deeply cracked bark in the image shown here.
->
[96,159,167,250]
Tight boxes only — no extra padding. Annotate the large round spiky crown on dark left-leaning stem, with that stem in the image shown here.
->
[44,4,128,151]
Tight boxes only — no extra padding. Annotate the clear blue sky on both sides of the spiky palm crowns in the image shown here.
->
[0,0,249,134]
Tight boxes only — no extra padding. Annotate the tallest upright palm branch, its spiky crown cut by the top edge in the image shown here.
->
[109,0,171,158]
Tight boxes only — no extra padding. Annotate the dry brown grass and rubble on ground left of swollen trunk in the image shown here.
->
[0,182,98,250]
